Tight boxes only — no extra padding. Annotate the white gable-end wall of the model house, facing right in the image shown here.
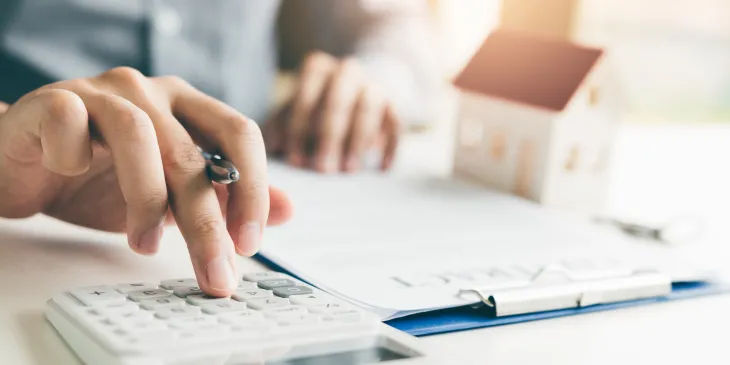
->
[541,60,621,214]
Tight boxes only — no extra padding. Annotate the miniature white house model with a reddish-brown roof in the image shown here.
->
[454,30,618,213]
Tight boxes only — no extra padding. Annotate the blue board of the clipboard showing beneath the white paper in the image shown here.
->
[254,254,730,336]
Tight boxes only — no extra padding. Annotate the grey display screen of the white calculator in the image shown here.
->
[266,346,412,365]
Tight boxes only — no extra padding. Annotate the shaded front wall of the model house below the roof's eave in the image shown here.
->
[454,92,555,200]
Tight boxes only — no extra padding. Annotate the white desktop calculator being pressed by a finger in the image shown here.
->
[46,272,430,365]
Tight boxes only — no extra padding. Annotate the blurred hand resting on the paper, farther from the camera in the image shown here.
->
[264,52,400,173]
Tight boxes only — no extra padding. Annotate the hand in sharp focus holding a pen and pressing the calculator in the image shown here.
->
[0,68,291,296]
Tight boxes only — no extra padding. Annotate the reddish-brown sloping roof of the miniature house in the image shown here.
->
[454,30,603,111]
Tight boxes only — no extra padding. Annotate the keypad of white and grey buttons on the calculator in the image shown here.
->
[54,272,380,352]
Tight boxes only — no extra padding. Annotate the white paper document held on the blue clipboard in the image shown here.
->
[262,164,707,320]
